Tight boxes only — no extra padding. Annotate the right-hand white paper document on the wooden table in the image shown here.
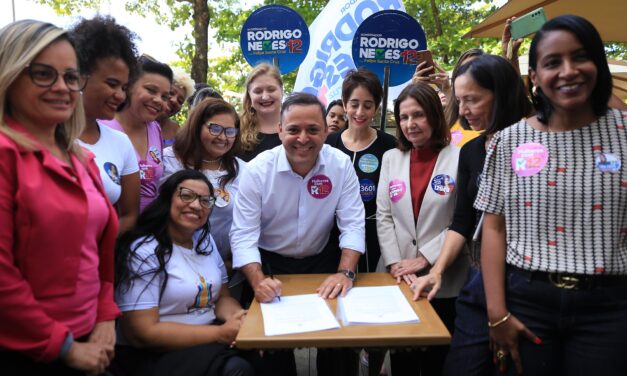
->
[337,286,420,325]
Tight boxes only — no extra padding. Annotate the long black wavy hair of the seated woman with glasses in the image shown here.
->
[115,170,213,299]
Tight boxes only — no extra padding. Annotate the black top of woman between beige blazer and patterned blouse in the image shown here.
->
[449,135,486,240]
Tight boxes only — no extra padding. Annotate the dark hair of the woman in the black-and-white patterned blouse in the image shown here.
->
[529,14,612,124]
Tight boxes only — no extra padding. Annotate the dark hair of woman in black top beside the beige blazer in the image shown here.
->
[453,54,531,134]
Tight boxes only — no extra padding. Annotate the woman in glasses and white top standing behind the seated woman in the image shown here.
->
[162,98,246,284]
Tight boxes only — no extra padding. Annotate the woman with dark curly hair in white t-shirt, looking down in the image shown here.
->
[70,16,139,232]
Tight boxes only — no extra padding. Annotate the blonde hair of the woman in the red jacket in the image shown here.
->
[0,20,85,157]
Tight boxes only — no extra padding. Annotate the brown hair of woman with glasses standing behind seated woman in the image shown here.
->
[172,98,241,188]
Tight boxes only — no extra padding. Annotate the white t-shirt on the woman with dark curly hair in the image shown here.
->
[77,124,139,205]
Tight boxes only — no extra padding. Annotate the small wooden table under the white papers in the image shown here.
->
[235,273,451,349]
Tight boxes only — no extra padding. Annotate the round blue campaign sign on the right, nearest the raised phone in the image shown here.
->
[353,10,427,86]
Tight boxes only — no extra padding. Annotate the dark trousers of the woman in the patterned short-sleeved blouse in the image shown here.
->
[498,267,627,376]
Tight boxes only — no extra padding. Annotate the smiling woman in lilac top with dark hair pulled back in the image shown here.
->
[102,55,172,211]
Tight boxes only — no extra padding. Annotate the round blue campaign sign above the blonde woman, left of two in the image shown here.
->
[240,5,309,74]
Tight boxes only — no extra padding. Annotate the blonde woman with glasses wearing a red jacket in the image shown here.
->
[0,20,119,375]
